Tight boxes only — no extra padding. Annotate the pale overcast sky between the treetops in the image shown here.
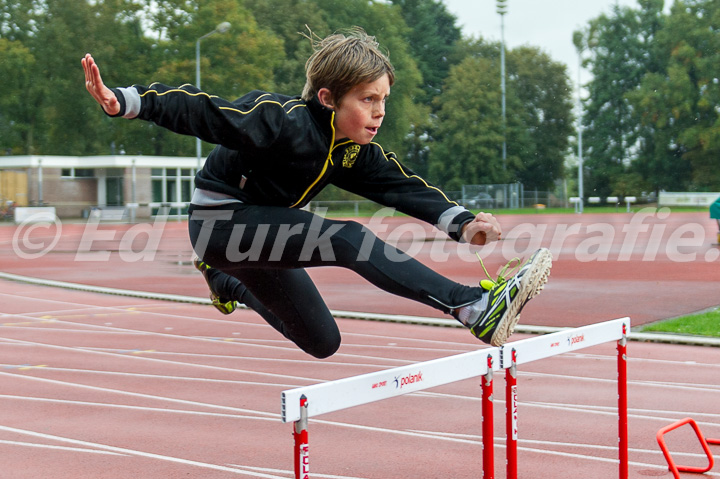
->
[443,0,672,85]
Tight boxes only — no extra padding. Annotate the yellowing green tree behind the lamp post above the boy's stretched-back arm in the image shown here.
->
[95,0,283,156]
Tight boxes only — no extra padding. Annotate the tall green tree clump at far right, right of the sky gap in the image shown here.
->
[573,0,720,196]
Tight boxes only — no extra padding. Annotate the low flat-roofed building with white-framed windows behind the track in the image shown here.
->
[0,155,198,218]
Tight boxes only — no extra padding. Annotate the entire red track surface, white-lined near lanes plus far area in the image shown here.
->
[0,214,720,479]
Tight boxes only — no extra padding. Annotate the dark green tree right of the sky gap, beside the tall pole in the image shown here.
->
[576,0,662,196]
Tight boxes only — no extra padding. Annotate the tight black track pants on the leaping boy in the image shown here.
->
[189,204,482,358]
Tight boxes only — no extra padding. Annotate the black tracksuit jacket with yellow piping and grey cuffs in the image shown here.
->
[113,83,474,240]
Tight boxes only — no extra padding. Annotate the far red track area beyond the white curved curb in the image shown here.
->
[0,209,720,327]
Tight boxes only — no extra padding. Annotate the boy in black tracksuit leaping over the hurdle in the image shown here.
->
[82,28,552,358]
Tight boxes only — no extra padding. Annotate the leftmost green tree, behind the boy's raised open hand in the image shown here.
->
[0,0,152,154]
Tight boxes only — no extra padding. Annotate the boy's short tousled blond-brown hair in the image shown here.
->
[302,27,395,104]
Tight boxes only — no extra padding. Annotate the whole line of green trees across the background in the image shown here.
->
[0,0,720,196]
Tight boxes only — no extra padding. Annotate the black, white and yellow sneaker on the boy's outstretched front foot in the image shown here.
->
[466,248,552,346]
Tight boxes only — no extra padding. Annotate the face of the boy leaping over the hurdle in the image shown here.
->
[334,75,390,145]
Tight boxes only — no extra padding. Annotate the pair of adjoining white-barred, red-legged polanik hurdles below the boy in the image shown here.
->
[282,318,630,479]
